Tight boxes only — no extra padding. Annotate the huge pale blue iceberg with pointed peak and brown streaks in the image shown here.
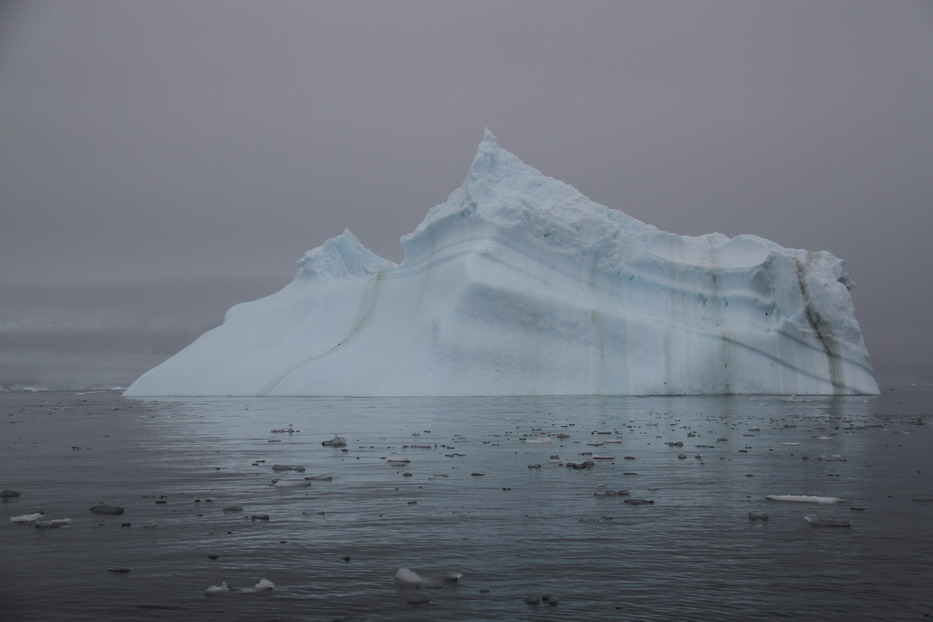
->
[125,130,878,396]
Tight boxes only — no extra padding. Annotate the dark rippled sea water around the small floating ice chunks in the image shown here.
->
[0,387,933,621]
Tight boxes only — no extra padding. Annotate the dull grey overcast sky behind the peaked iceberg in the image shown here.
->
[0,0,933,386]
